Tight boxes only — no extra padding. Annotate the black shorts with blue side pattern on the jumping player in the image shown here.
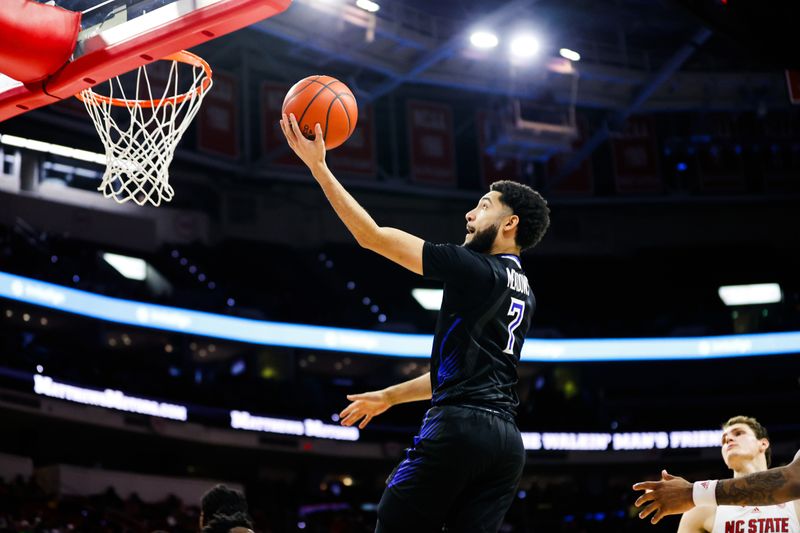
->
[376,406,525,533]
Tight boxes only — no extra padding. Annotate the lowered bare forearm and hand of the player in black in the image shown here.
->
[339,372,431,429]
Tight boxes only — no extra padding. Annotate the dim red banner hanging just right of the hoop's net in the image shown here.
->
[197,70,239,159]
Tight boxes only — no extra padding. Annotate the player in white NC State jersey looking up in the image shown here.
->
[678,416,800,533]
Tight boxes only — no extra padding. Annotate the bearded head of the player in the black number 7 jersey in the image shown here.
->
[464,180,550,253]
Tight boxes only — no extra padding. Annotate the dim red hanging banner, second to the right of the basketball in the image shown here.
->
[408,100,456,187]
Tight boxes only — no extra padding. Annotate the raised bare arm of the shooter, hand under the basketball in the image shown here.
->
[281,115,424,274]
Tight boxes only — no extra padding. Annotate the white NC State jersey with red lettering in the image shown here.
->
[711,503,800,533]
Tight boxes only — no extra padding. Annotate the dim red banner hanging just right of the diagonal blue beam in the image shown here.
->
[611,116,663,194]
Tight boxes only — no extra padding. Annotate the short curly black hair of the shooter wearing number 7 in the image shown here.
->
[489,180,550,250]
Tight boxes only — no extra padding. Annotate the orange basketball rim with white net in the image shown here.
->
[75,51,212,206]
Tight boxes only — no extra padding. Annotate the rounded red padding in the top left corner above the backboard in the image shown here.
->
[0,0,81,83]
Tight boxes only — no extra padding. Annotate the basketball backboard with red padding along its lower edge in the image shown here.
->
[0,0,291,121]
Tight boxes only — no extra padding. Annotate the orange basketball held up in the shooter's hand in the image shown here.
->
[282,75,358,150]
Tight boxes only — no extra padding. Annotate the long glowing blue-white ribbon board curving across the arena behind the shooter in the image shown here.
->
[0,272,800,366]
